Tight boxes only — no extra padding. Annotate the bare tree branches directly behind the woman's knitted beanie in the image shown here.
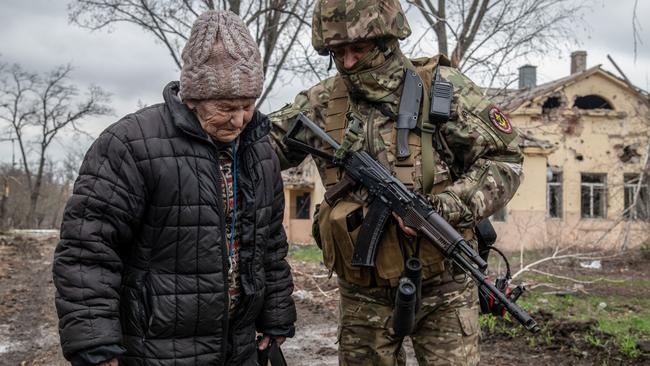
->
[68,0,314,105]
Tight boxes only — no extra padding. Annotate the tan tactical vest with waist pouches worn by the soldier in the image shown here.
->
[318,57,473,286]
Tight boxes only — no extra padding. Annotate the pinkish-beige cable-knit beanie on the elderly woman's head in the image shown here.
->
[180,10,264,100]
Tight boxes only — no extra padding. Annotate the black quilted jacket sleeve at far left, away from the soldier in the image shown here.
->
[52,123,145,359]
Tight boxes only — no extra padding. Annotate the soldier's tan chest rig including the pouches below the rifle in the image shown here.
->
[319,57,452,286]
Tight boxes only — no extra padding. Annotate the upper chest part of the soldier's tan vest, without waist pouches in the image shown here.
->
[323,56,451,194]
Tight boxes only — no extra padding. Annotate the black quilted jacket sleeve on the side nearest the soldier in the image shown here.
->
[256,149,296,337]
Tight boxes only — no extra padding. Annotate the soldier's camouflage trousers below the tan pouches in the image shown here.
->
[338,277,479,366]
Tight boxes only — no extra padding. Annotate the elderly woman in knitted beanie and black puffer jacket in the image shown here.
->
[53,11,296,365]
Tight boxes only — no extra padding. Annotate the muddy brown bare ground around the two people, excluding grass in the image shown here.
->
[0,235,650,366]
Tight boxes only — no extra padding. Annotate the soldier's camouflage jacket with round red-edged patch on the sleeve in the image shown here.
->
[269,55,523,229]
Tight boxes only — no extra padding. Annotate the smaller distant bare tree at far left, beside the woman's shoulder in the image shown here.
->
[0,65,112,225]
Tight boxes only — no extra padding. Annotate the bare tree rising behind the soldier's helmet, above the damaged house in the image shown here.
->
[407,0,583,88]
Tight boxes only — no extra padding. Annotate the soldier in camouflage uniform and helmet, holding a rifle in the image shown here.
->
[270,0,523,365]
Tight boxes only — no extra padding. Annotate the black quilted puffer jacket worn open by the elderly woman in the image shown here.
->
[53,82,296,365]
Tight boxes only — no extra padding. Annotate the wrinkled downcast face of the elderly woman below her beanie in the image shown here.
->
[187,98,255,142]
